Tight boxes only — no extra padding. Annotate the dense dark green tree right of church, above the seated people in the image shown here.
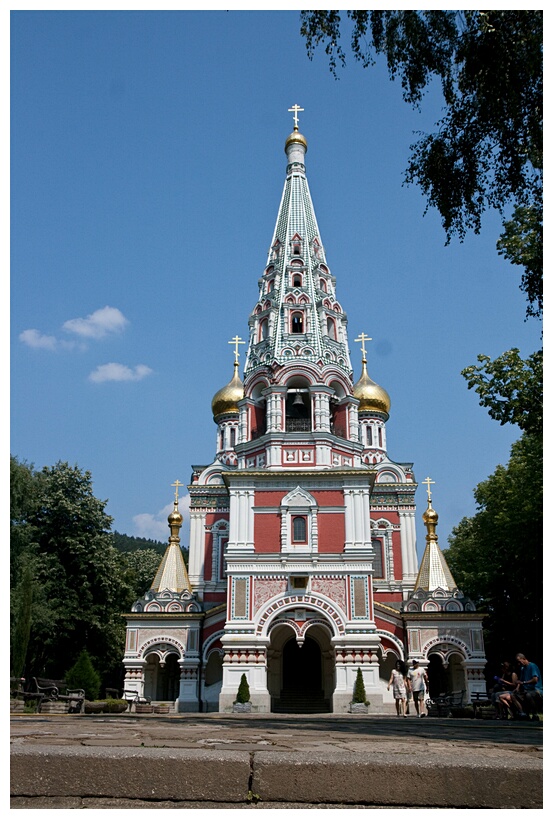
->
[445,433,543,664]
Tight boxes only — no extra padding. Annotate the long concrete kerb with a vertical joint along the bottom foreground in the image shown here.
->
[11,745,542,808]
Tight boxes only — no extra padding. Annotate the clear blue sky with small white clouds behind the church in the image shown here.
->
[10,10,541,552]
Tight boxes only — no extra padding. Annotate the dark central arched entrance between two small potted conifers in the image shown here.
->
[267,625,335,714]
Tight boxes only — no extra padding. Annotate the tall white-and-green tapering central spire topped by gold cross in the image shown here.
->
[244,104,352,379]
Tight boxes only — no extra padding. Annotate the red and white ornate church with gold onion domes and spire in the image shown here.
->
[123,105,486,714]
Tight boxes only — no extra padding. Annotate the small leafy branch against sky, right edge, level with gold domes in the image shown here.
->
[461,347,543,435]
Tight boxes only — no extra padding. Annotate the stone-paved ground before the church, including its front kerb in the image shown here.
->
[11,714,542,809]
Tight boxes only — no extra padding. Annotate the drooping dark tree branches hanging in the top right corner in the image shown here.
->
[300,10,543,316]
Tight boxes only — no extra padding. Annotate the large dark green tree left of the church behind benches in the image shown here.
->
[12,462,133,678]
